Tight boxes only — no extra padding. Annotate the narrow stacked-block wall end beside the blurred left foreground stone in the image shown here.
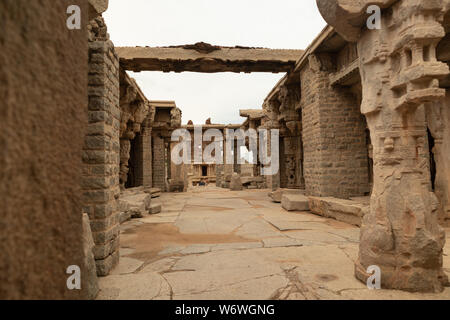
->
[82,18,120,276]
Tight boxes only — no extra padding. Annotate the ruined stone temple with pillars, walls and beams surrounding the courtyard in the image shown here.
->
[0,0,450,299]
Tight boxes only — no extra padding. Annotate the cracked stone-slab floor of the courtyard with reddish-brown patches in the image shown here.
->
[98,187,450,300]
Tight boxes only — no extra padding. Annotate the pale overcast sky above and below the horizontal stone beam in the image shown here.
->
[104,0,325,124]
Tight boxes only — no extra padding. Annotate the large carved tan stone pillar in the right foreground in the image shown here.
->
[356,0,449,292]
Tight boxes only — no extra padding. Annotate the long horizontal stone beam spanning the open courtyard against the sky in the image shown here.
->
[116,43,303,73]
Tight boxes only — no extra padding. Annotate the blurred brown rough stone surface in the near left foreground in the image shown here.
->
[0,0,88,299]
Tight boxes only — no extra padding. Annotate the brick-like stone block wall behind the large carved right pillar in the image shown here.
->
[301,55,370,198]
